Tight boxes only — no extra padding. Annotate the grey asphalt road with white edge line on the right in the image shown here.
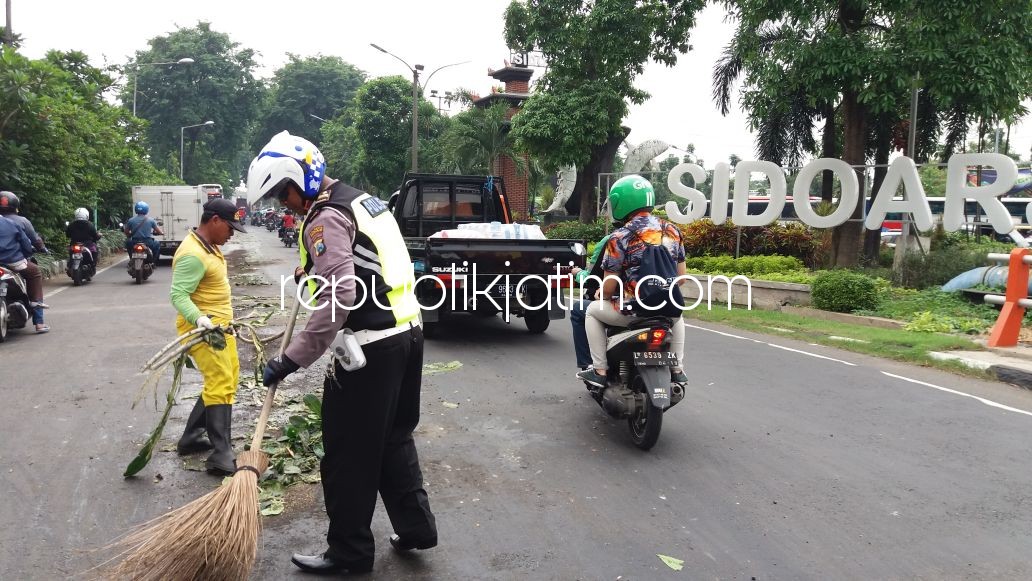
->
[0,230,1032,580]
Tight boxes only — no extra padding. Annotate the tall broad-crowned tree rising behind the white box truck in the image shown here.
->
[122,22,265,190]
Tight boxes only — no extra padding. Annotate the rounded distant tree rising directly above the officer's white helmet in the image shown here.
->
[253,55,365,151]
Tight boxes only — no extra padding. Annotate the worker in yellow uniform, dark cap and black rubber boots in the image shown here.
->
[169,198,245,476]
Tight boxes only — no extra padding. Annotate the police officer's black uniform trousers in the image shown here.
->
[321,327,438,563]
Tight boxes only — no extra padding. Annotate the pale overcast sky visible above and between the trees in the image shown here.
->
[11,0,1032,166]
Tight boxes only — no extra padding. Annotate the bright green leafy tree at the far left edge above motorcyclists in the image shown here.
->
[0,49,169,241]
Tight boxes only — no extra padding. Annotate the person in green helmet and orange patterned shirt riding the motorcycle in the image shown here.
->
[577,175,688,387]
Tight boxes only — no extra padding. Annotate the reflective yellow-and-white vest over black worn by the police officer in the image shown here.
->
[298,182,419,331]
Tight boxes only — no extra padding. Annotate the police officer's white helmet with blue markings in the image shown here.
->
[248,131,326,201]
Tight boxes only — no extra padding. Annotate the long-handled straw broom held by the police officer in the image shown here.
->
[106,300,301,581]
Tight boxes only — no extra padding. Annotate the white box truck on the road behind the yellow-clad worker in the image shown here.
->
[132,186,207,256]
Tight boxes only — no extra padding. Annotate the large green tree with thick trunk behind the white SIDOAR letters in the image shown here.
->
[724,0,1032,265]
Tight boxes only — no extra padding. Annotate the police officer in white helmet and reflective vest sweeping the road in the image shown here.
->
[248,131,438,573]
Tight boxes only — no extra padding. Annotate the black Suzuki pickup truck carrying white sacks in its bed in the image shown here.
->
[388,173,586,336]
